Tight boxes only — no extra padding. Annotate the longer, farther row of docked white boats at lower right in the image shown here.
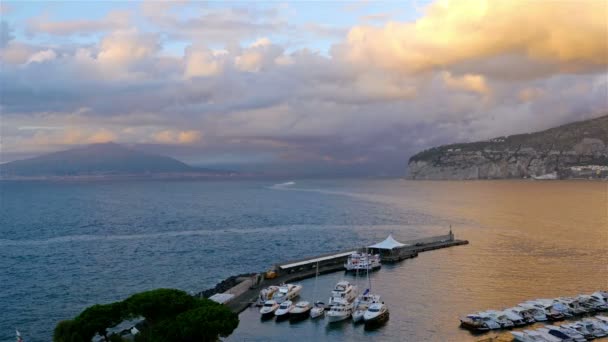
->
[460,291,608,332]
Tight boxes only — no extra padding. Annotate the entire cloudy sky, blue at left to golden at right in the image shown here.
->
[0,0,608,176]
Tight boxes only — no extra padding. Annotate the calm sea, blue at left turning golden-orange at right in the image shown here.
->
[0,180,608,341]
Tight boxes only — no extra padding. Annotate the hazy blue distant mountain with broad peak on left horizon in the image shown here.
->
[0,142,226,178]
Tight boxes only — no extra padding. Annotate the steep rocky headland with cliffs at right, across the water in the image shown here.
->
[409,115,608,179]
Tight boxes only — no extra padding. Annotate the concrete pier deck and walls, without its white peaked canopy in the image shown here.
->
[205,232,469,313]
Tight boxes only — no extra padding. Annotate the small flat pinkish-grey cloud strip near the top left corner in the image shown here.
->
[26,11,129,36]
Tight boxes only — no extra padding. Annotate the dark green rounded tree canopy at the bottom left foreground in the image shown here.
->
[53,289,239,342]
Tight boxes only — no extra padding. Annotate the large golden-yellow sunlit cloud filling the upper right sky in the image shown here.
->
[341,0,608,77]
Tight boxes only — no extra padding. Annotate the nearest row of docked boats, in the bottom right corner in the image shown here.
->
[511,315,608,342]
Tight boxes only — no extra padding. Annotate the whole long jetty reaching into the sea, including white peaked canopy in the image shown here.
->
[198,229,469,313]
